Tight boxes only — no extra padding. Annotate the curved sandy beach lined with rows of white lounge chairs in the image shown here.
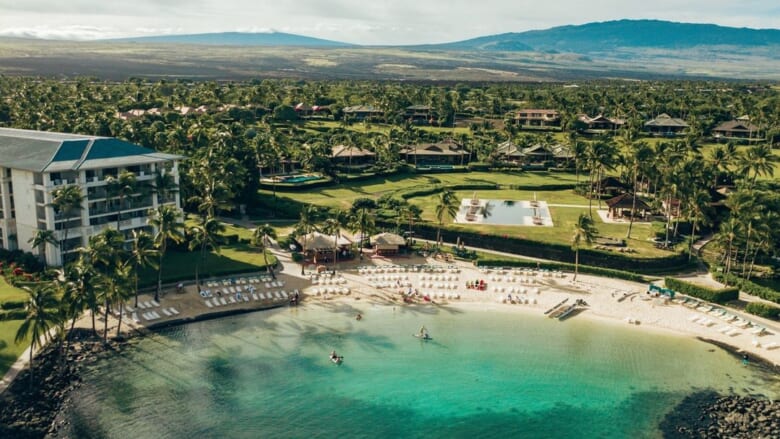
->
[90,253,780,366]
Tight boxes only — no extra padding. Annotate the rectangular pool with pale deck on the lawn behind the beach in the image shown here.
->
[455,198,553,227]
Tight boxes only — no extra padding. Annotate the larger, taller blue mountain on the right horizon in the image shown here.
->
[430,20,780,53]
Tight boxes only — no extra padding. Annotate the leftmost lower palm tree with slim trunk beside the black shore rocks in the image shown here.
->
[14,284,60,389]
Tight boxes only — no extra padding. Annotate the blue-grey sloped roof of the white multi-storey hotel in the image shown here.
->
[0,128,182,172]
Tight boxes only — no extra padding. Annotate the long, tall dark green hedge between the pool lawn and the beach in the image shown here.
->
[406,221,689,274]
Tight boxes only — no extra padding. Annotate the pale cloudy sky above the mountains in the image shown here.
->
[0,0,780,45]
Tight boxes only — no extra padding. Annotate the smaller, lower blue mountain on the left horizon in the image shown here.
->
[103,32,352,47]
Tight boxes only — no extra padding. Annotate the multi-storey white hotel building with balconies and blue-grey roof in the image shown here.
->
[0,128,183,265]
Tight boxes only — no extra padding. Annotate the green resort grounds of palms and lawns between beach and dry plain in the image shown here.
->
[0,77,780,384]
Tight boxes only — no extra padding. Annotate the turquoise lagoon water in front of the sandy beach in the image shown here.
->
[61,302,780,438]
